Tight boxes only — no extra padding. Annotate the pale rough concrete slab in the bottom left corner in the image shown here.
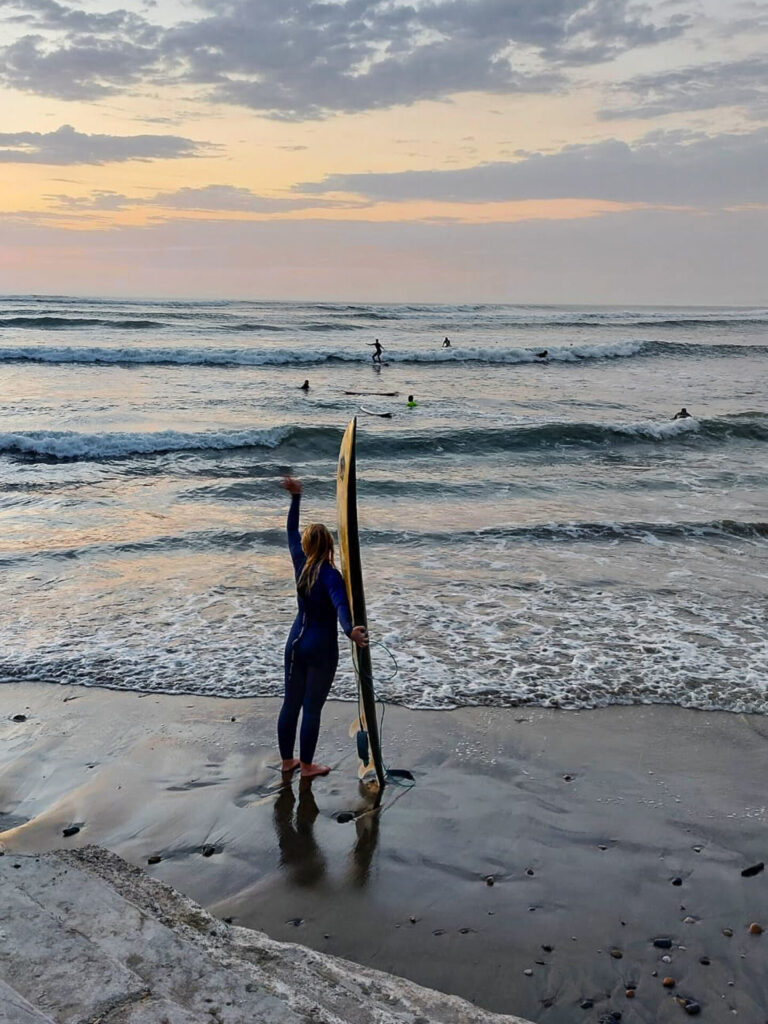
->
[0,847,525,1024]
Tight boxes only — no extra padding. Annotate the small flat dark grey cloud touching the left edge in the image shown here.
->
[0,125,211,166]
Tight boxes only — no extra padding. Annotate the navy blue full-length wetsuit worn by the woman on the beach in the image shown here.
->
[278,495,352,764]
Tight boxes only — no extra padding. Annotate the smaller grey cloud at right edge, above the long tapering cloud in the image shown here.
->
[599,53,768,120]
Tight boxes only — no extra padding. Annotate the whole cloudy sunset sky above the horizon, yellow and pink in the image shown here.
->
[0,0,768,305]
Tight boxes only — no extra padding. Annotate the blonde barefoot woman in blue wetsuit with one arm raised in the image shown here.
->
[278,476,368,778]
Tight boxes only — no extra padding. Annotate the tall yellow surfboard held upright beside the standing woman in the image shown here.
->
[336,417,386,791]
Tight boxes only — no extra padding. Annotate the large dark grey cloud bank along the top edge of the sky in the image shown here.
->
[0,0,686,120]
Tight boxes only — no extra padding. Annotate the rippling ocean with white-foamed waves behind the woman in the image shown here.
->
[0,296,768,714]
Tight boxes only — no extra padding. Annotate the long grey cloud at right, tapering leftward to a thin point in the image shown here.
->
[295,129,768,206]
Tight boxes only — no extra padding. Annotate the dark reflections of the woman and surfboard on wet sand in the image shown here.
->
[273,776,379,888]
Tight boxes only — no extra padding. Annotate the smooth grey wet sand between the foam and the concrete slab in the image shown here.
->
[0,684,768,1024]
